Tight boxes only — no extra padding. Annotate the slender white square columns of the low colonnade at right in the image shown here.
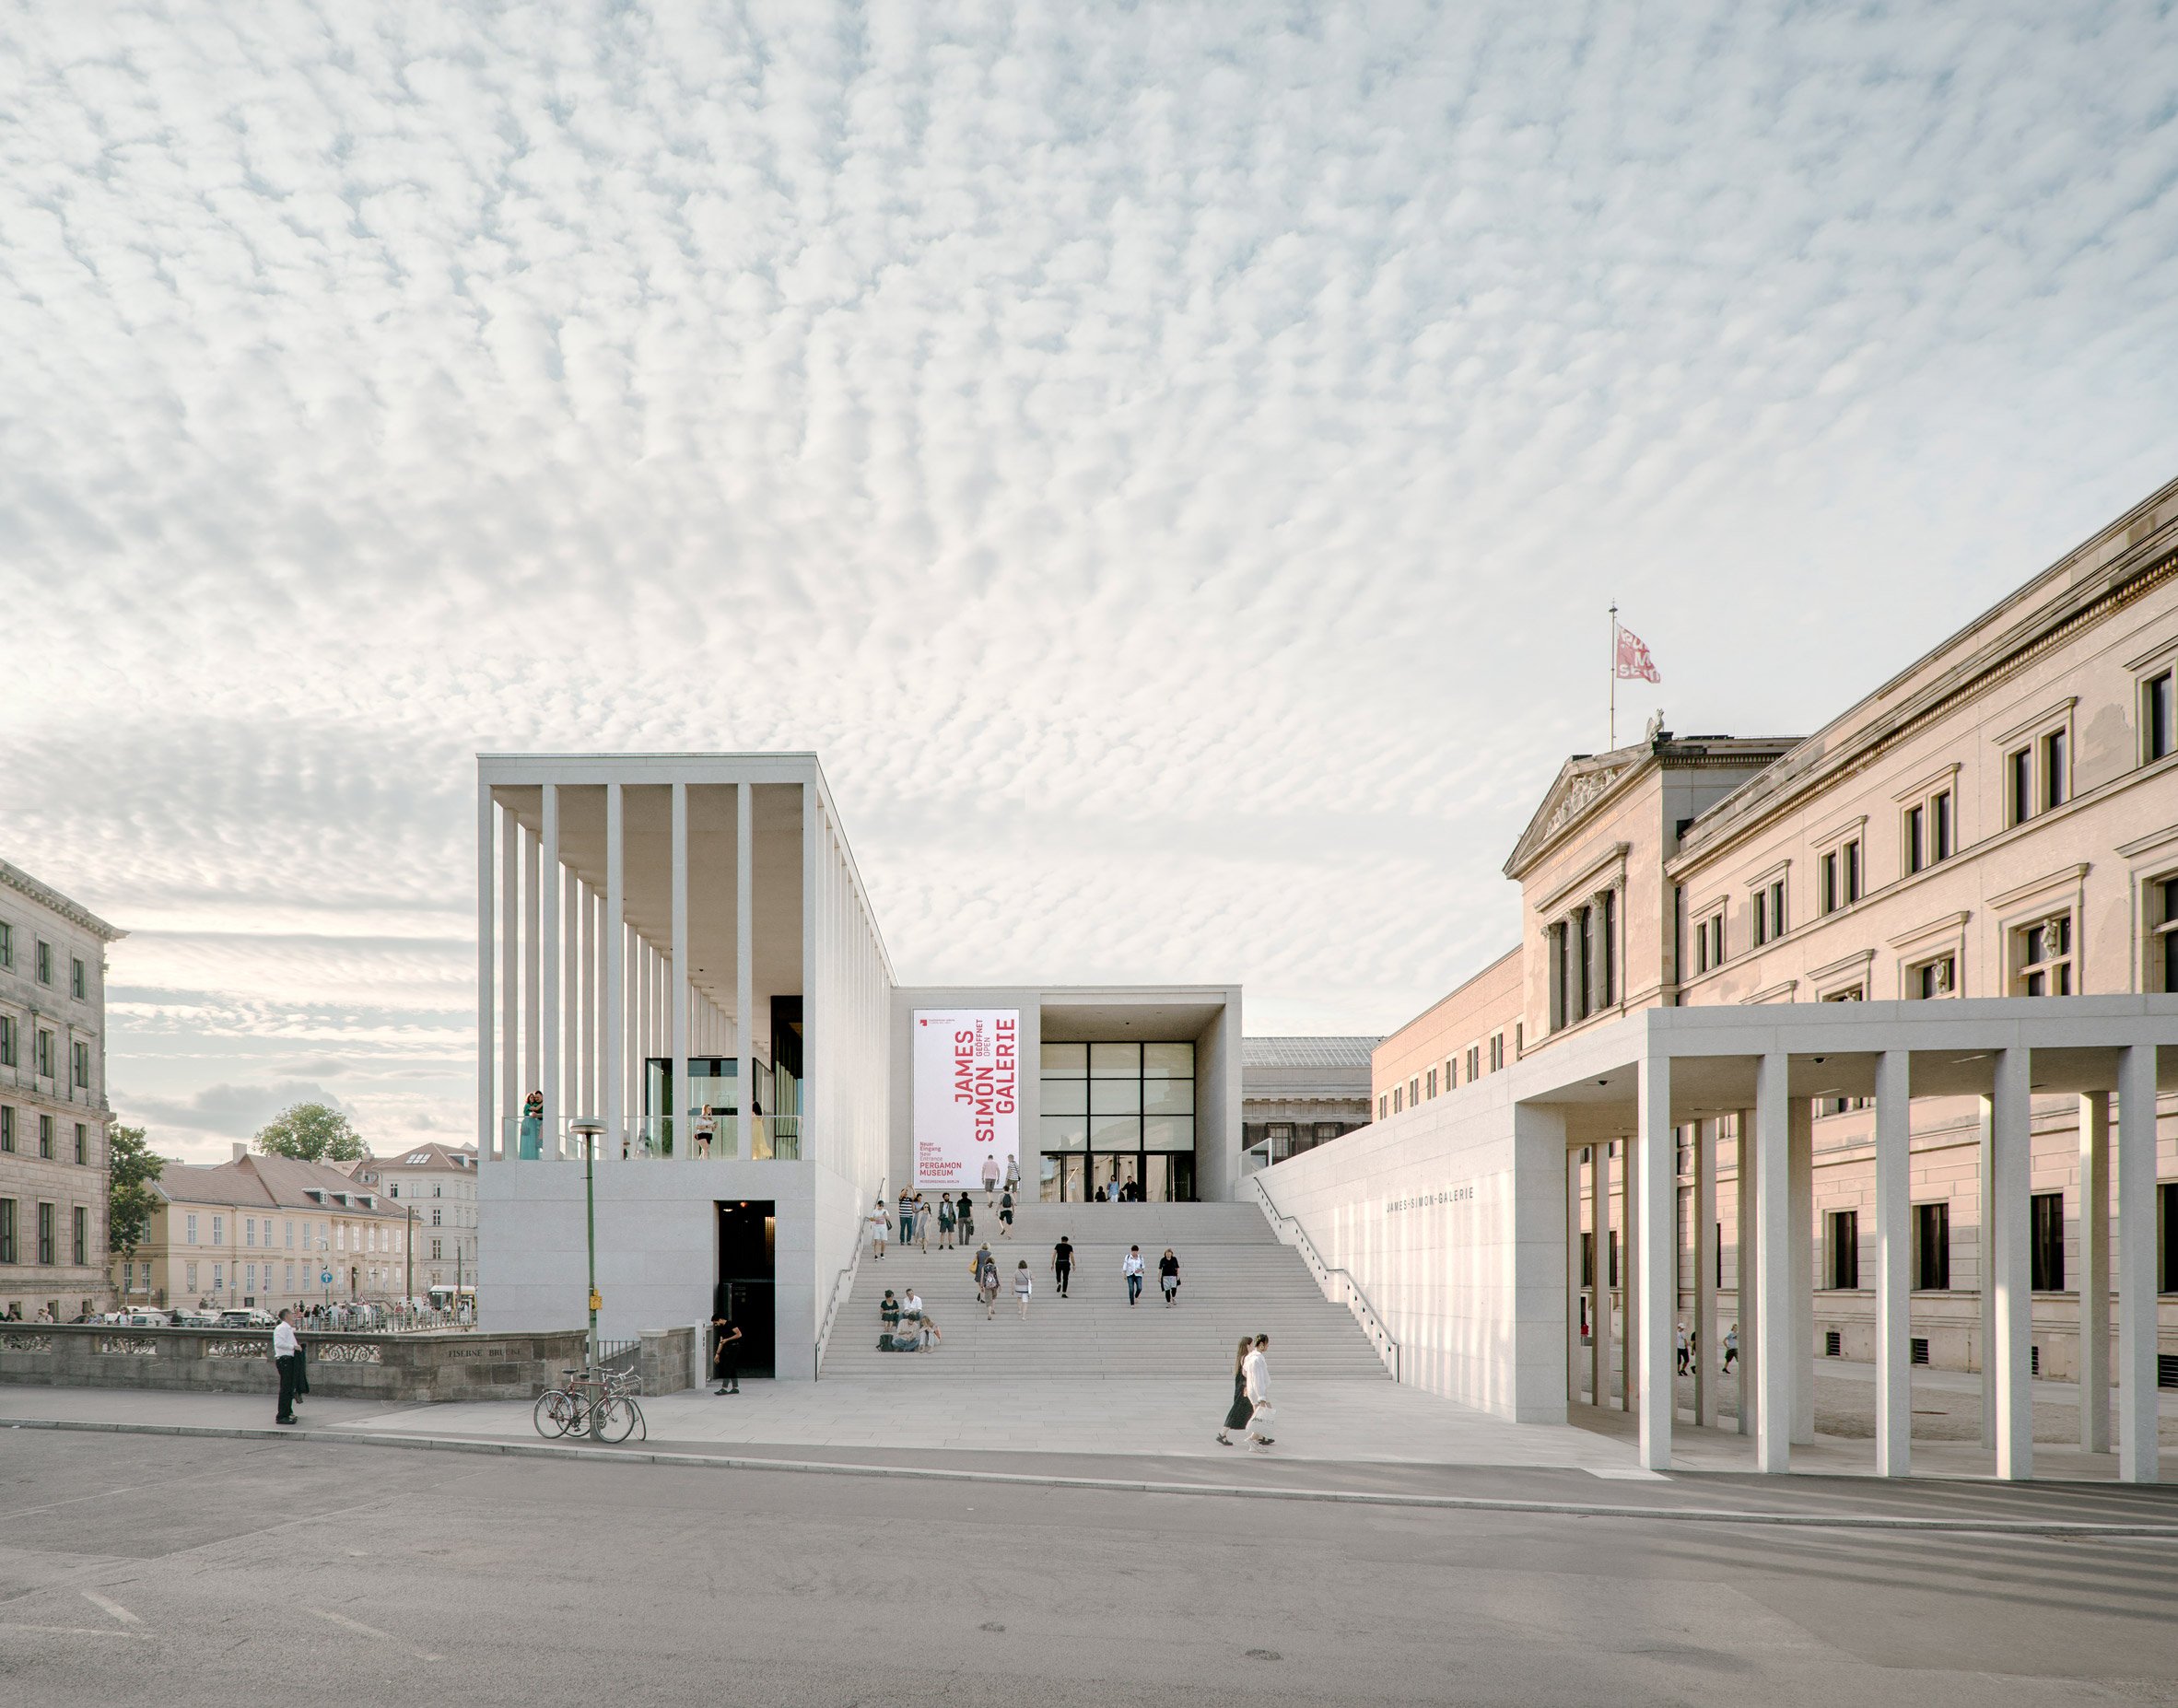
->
[1566,1044,2159,1481]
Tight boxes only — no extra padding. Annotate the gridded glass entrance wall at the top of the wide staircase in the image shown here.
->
[1039,1044,1196,1205]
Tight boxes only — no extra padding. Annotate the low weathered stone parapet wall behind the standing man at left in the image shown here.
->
[0,1322,588,1405]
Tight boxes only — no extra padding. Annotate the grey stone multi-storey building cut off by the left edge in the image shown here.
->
[0,860,124,1320]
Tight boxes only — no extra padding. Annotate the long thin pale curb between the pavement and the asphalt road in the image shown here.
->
[0,1418,2178,1540]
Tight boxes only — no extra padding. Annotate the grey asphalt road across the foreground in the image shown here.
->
[0,1432,2178,1708]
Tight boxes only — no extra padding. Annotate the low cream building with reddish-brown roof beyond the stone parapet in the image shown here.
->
[113,1144,409,1312]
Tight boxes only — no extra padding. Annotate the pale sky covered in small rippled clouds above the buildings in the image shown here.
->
[0,0,2178,1157]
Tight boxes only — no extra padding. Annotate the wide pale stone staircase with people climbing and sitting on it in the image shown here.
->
[824,1196,1386,1381]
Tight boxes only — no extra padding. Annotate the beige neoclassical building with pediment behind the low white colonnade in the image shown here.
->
[1257,470,2178,1481]
